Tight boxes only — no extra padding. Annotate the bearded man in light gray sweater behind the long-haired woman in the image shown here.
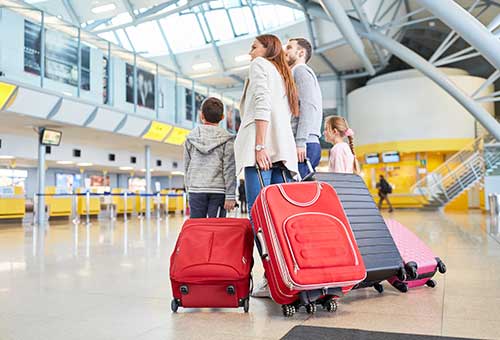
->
[286,38,323,178]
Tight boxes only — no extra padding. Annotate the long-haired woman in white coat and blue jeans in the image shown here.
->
[234,34,299,296]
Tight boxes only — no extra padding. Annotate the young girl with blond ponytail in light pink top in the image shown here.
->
[324,116,359,174]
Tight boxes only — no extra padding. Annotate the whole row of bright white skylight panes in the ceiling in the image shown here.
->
[95,0,304,56]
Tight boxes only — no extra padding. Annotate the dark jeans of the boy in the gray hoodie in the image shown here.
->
[189,192,226,218]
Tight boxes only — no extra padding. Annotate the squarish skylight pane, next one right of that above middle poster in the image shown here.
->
[160,14,205,53]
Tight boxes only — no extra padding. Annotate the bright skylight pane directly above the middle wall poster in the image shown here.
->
[126,21,168,56]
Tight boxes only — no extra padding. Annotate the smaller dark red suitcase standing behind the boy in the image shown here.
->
[170,218,254,312]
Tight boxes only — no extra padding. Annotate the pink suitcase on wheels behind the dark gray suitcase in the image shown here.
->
[385,219,446,293]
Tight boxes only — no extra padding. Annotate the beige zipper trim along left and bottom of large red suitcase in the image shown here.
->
[261,187,366,290]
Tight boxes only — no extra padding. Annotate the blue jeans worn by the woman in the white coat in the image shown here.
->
[245,166,293,254]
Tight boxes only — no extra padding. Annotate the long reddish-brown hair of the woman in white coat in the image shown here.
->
[256,34,299,117]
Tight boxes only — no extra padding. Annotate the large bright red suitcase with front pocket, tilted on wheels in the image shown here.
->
[251,182,366,316]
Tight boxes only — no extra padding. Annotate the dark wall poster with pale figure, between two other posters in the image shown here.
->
[125,64,155,110]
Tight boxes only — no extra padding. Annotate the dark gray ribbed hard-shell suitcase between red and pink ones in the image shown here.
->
[314,172,406,293]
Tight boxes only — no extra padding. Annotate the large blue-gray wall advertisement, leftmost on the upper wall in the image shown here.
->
[24,20,90,91]
